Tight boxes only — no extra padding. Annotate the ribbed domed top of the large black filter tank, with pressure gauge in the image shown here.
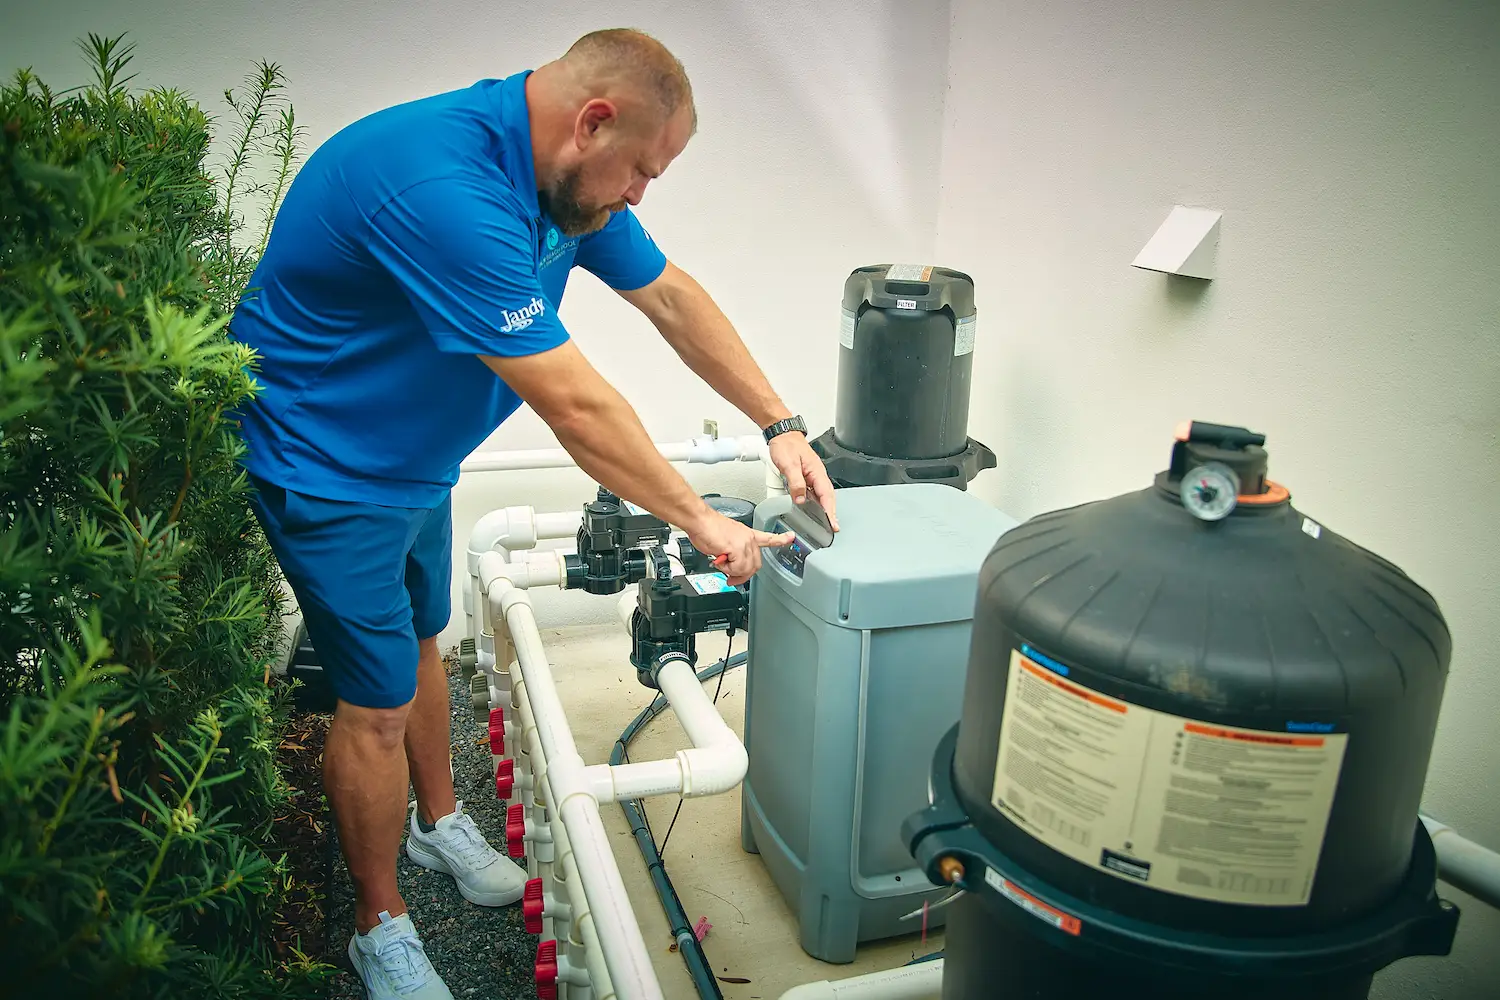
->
[977,421,1452,714]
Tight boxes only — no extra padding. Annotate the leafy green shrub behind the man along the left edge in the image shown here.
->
[0,36,330,999]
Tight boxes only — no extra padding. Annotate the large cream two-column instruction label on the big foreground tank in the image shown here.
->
[992,649,1349,906]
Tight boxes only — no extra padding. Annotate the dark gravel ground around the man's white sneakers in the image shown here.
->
[327,661,537,1000]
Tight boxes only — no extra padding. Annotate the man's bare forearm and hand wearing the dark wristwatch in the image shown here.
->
[620,261,837,526]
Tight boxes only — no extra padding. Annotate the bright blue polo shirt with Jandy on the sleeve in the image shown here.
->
[230,70,666,507]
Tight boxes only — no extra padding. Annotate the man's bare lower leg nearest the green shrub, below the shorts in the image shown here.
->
[323,700,411,934]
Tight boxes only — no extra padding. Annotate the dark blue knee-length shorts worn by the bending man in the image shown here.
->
[251,475,453,708]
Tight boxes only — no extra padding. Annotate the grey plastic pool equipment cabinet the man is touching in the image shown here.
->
[741,483,1017,963]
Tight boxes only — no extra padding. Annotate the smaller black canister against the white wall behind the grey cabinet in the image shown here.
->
[812,264,995,489]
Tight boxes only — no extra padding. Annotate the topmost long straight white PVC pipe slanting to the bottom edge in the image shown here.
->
[480,575,662,1000]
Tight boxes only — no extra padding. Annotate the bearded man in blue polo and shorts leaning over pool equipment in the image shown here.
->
[231,30,834,1000]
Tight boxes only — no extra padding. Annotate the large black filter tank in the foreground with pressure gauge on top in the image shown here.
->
[903,423,1458,1000]
